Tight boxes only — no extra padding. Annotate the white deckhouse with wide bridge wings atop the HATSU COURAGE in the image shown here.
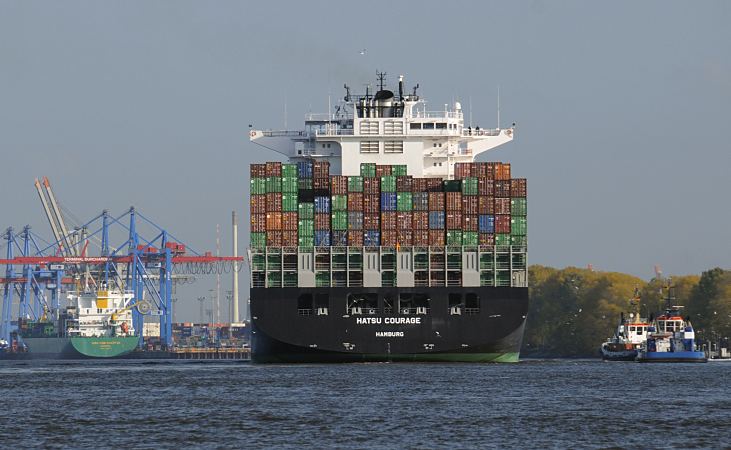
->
[249,73,515,179]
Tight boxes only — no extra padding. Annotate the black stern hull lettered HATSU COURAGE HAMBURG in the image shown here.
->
[251,287,528,363]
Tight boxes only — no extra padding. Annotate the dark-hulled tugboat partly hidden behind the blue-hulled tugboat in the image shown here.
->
[601,289,649,361]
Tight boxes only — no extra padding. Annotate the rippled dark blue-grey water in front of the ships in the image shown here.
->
[0,361,731,449]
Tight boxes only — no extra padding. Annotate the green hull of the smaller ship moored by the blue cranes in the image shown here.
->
[23,336,139,359]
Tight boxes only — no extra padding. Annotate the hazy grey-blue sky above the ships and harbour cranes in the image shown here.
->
[0,0,731,320]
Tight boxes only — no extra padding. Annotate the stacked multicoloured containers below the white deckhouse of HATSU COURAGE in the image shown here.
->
[251,161,527,248]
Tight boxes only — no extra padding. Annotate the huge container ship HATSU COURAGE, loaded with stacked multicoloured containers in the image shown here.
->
[248,74,528,363]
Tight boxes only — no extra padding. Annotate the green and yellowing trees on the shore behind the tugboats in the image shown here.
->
[521,265,731,357]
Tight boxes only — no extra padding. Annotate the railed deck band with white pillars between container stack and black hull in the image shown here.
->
[249,245,528,288]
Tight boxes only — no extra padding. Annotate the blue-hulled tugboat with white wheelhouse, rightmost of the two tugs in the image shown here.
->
[637,287,708,362]
